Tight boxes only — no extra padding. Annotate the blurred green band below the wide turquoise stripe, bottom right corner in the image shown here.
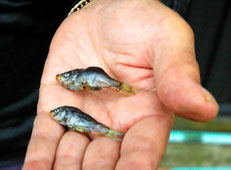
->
[161,143,231,168]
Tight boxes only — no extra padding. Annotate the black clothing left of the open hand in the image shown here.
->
[0,0,74,167]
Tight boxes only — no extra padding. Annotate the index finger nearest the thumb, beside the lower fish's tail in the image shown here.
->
[116,114,173,170]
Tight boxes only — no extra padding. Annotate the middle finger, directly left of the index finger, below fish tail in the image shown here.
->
[83,137,120,170]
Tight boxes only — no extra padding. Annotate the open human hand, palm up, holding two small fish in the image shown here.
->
[23,0,218,170]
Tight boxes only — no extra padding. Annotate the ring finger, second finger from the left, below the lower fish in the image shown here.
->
[54,131,90,170]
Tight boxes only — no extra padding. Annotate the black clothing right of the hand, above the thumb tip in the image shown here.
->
[162,0,231,116]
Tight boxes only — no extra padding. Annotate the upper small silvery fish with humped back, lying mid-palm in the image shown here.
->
[56,67,136,95]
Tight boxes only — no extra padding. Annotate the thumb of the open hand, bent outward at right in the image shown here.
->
[153,14,218,121]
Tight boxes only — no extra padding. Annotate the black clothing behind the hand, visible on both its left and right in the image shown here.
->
[0,0,231,167]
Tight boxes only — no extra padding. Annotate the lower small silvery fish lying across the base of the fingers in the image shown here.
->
[50,106,124,141]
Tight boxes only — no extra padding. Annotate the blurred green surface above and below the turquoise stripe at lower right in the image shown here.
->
[160,117,231,168]
